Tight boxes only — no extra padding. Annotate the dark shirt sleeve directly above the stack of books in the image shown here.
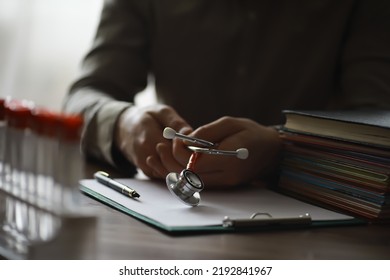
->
[341,0,390,109]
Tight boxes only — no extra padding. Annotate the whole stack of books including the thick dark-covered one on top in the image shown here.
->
[278,110,390,222]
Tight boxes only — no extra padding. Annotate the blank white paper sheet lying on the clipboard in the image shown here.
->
[80,179,352,227]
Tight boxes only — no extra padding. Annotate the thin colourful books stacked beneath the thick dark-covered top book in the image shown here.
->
[278,131,390,221]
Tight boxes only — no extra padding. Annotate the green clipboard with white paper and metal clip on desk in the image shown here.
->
[79,179,365,234]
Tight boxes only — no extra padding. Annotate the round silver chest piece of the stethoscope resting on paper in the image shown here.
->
[166,169,204,206]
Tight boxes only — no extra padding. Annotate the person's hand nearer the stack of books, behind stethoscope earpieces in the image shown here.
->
[169,117,281,187]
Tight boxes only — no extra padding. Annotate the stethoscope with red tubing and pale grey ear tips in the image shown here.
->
[163,127,249,206]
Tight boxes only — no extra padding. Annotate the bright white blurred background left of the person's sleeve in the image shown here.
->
[0,0,103,110]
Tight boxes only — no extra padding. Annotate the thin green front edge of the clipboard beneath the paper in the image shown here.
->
[79,184,368,235]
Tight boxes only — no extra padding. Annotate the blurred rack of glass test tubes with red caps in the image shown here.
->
[0,99,97,259]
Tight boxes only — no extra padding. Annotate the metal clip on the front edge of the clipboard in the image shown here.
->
[222,212,312,228]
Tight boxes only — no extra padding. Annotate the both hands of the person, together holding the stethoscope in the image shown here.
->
[116,105,280,187]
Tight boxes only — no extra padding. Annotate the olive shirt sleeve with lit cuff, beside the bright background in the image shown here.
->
[64,0,149,173]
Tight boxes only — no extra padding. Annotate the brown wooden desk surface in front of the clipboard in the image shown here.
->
[77,163,390,260]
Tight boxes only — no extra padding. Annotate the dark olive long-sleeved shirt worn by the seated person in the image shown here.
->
[64,0,390,172]
